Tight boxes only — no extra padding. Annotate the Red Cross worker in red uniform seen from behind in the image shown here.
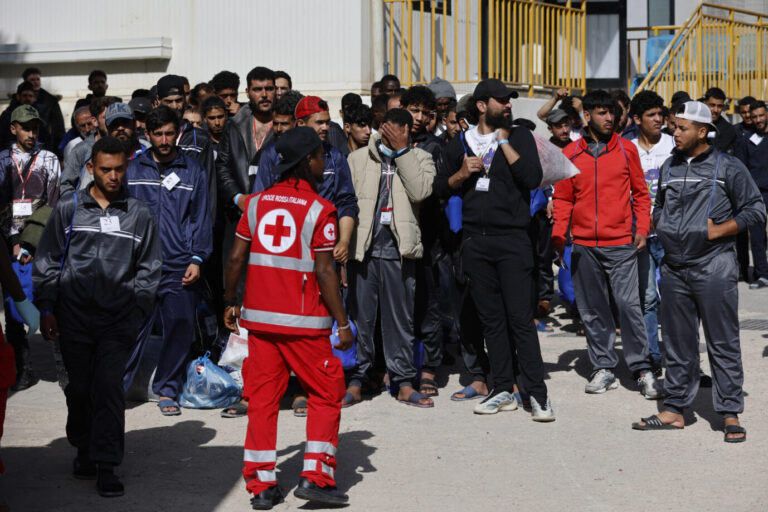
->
[224,127,352,510]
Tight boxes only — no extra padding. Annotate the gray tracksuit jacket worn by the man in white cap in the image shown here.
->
[653,148,766,266]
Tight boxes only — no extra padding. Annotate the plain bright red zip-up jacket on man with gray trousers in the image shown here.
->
[552,134,651,247]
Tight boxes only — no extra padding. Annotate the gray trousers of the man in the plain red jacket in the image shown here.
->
[571,244,652,374]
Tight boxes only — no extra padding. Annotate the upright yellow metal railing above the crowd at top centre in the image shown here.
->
[383,0,586,96]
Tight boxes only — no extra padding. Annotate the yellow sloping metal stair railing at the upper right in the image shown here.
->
[637,3,768,113]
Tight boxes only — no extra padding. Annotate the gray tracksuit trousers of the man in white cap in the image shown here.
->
[661,251,744,415]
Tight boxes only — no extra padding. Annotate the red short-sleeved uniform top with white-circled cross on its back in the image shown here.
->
[237,180,337,336]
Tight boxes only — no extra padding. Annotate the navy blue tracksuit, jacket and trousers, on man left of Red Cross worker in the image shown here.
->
[124,150,213,399]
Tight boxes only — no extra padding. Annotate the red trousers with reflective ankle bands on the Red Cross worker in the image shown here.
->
[243,333,345,494]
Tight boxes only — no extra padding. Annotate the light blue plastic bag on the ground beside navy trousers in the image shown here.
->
[179,352,240,409]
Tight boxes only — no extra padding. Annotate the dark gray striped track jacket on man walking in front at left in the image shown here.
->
[32,185,162,340]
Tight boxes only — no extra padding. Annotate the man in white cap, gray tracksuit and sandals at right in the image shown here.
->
[632,101,765,443]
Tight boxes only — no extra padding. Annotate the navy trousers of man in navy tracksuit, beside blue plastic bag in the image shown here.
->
[125,271,199,399]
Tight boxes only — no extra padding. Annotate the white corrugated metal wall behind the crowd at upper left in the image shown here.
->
[0,0,376,114]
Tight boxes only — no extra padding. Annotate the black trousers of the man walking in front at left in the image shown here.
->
[61,329,135,465]
